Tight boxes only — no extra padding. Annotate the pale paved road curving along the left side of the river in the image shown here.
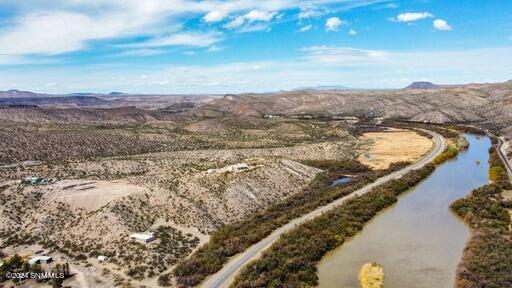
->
[201,130,446,288]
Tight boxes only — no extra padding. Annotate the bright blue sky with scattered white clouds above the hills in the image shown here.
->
[0,0,512,94]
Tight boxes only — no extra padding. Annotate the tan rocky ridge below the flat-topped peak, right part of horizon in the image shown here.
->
[202,81,512,123]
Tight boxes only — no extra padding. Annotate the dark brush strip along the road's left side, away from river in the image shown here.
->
[169,160,408,287]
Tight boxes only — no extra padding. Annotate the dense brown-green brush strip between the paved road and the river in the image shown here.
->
[232,164,435,287]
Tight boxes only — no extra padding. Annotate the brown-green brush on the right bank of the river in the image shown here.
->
[451,143,512,288]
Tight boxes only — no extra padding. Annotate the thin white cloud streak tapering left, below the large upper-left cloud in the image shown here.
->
[130,32,221,47]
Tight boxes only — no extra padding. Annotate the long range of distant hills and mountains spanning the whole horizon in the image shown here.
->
[0,81,512,127]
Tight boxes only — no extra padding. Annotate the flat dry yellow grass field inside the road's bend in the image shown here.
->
[357,129,433,169]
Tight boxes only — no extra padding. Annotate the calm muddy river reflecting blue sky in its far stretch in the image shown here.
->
[318,135,491,288]
